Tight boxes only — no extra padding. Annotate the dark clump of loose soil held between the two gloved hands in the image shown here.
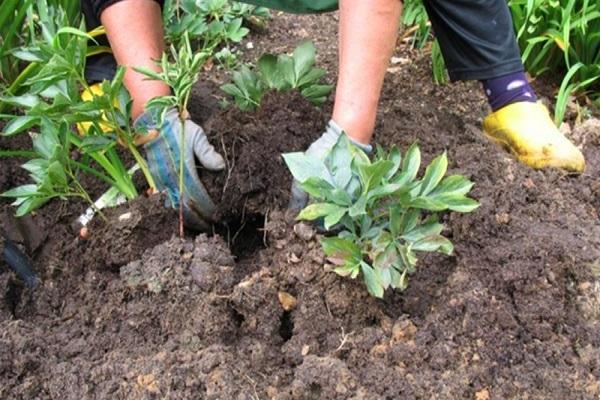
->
[201,92,325,221]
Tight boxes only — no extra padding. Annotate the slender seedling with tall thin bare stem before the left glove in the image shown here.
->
[135,35,210,237]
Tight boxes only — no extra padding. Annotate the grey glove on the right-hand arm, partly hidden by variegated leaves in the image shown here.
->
[288,120,373,211]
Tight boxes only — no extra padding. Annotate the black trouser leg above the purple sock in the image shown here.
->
[424,0,524,81]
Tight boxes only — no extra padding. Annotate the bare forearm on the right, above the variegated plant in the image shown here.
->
[333,0,402,144]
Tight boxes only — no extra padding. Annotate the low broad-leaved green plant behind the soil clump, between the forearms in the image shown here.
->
[221,41,333,111]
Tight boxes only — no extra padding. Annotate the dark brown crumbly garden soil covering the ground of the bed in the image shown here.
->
[0,14,600,400]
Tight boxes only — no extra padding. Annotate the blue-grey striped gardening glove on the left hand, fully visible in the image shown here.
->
[135,108,225,230]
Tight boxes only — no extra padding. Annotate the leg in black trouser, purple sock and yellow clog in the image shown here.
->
[424,0,585,172]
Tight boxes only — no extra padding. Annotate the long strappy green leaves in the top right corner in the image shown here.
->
[509,0,600,124]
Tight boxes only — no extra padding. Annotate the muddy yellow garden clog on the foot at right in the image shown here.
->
[483,101,585,172]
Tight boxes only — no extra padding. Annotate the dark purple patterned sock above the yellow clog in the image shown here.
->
[480,72,537,111]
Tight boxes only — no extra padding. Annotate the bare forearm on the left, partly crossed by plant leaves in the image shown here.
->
[100,0,170,119]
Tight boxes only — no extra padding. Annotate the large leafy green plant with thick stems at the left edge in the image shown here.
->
[0,0,154,215]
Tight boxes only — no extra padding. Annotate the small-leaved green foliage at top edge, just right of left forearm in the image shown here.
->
[163,0,270,68]
